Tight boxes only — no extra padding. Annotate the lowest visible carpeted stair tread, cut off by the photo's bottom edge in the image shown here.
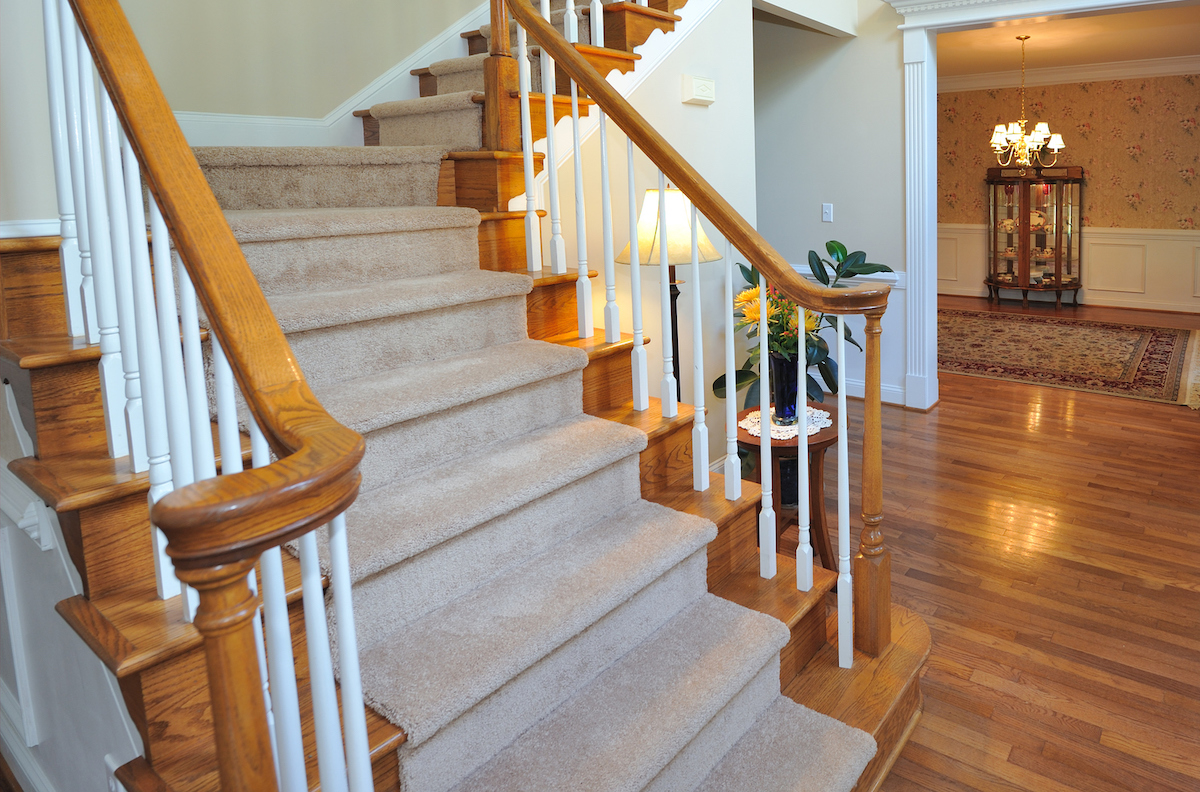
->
[696,696,876,792]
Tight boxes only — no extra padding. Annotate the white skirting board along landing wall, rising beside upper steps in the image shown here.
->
[175,2,491,145]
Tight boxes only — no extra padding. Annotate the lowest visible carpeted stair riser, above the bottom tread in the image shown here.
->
[644,655,782,792]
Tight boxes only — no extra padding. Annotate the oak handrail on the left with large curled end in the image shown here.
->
[71,0,365,569]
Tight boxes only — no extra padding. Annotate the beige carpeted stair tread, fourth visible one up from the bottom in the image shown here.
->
[347,415,644,581]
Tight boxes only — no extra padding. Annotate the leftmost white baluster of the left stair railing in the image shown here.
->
[42,0,86,336]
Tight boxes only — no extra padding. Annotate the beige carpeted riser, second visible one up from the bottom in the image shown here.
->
[400,551,704,792]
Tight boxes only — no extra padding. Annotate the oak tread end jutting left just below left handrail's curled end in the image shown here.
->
[54,552,309,678]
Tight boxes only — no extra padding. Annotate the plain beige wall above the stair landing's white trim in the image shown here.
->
[121,0,480,118]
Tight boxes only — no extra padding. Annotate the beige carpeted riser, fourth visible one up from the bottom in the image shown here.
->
[352,372,582,492]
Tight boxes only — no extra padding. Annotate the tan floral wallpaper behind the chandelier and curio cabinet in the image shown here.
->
[937,74,1200,229]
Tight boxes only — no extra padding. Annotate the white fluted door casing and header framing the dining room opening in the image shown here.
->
[888,0,1176,409]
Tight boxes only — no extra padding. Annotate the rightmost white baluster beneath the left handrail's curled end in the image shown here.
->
[329,514,374,792]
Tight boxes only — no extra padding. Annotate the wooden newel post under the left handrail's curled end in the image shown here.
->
[175,559,278,792]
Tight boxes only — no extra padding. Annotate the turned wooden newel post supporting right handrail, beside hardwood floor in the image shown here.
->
[851,311,892,656]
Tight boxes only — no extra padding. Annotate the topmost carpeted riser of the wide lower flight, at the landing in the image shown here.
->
[203,162,446,209]
